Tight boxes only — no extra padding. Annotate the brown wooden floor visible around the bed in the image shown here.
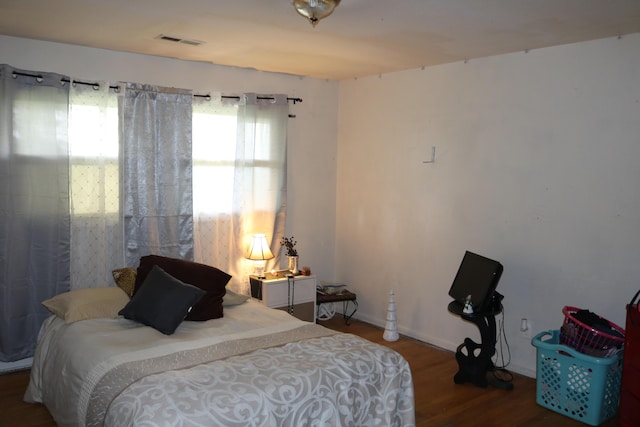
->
[0,316,617,427]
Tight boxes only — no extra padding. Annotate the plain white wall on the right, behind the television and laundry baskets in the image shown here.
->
[336,34,640,375]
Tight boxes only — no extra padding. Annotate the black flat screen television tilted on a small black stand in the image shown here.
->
[449,251,503,313]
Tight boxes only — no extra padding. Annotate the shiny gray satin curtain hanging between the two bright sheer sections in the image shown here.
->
[120,83,193,267]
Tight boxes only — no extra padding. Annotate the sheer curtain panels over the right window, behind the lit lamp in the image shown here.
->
[193,94,289,294]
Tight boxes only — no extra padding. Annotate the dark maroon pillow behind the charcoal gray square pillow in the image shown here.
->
[133,255,231,321]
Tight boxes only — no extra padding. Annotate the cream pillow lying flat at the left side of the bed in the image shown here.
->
[42,286,129,323]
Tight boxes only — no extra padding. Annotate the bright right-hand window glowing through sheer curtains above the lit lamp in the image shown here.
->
[192,101,284,216]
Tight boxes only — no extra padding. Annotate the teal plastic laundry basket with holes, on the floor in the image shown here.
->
[531,330,622,426]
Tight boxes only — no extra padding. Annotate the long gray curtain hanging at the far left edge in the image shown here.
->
[0,65,70,362]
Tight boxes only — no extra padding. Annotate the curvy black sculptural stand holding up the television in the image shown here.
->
[448,301,513,390]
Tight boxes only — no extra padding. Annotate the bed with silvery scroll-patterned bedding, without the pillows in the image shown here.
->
[25,258,415,427]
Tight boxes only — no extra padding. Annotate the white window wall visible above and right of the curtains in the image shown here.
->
[0,36,338,284]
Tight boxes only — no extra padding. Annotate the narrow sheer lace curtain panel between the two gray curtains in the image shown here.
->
[69,83,125,289]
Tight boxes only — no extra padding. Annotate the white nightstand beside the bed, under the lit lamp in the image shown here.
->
[249,276,316,322]
